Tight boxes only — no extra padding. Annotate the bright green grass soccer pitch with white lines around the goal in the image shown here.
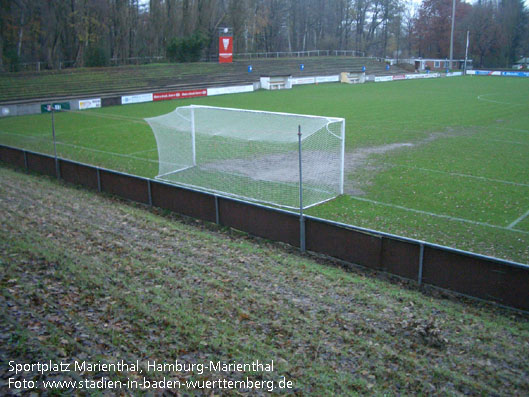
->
[0,76,529,263]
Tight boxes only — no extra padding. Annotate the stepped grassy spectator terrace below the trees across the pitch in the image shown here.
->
[0,57,405,104]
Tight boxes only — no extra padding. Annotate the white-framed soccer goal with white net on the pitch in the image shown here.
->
[145,105,345,209]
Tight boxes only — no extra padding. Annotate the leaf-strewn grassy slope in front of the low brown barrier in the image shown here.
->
[0,168,529,395]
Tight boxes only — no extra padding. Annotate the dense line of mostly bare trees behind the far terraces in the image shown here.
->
[0,0,529,70]
